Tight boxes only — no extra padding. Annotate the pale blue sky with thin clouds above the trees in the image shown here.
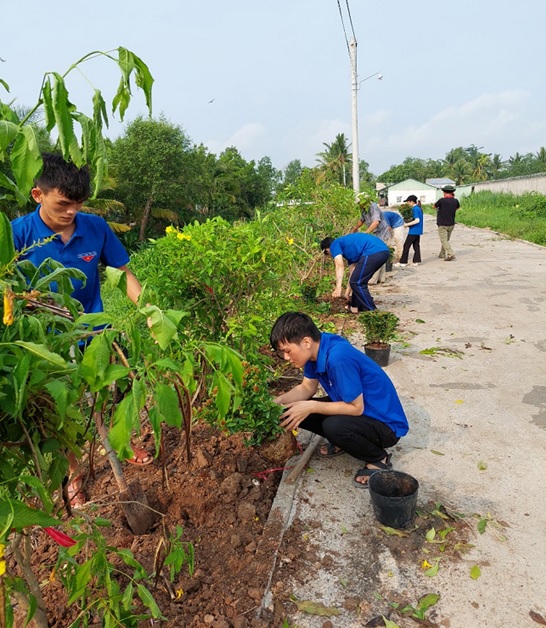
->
[0,0,546,175]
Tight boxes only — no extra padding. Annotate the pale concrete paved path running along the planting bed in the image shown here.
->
[262,216,546,628]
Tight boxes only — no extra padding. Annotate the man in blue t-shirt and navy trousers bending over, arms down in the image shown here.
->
[320,233,390,314]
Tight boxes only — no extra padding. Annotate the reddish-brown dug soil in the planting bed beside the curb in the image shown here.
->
[25,425,296,628]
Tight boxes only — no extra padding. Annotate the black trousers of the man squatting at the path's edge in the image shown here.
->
[299,397,400,463]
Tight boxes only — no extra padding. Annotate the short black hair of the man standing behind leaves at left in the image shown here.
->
[34,153,91,202]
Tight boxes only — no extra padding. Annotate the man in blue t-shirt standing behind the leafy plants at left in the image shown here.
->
[12,153,153,507]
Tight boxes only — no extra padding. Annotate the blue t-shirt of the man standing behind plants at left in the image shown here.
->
[11,205,129,313]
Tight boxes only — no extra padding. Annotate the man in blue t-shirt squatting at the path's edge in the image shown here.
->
[270,312,409,488]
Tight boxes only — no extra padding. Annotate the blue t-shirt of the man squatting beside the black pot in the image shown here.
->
[303,332,409,438]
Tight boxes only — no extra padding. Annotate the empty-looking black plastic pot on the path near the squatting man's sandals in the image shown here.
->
[368,471,419,528]
